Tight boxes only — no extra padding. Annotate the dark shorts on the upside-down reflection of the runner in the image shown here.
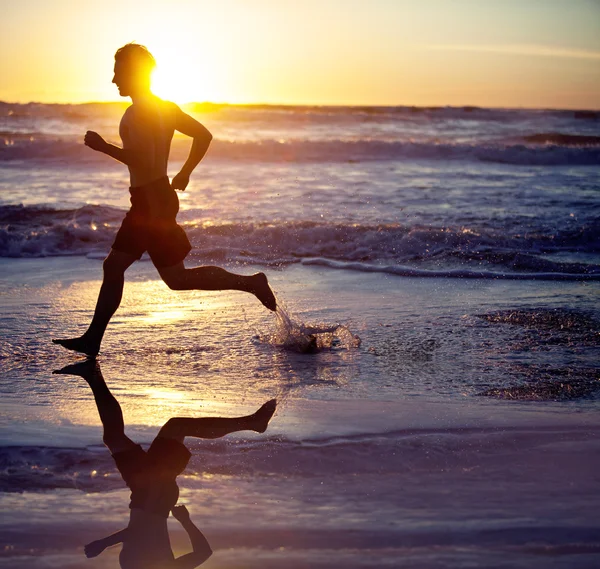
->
[113,437,191,518]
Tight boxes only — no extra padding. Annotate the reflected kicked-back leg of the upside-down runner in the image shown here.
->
[158,399,277,442]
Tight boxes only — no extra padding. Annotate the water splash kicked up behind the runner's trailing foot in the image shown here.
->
[266,302,361,354]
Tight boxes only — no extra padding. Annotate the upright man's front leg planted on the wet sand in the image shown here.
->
[52,249,137,358]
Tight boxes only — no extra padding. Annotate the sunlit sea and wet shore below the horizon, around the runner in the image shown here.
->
[0,102,600,569]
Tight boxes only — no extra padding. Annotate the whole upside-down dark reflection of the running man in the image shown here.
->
[55,360,276,569]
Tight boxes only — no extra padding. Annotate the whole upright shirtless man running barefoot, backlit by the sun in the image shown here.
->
[52,43,277,357]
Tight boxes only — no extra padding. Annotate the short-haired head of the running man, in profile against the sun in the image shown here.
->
[113,43,156,97]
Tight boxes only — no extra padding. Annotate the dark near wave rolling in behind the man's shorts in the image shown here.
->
[0,205,600,280]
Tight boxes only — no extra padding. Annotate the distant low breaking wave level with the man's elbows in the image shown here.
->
[0,134,600,166]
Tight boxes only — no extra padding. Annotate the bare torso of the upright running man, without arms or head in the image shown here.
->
[119,95,177,187]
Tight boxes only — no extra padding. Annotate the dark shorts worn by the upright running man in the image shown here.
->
[112,176,192,268]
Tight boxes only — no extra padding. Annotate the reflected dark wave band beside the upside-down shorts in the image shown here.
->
[0,427,596,492]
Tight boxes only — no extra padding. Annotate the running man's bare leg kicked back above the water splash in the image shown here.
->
[157,261,277,310]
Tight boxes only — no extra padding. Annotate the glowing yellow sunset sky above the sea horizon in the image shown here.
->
[0,0,600,109]
